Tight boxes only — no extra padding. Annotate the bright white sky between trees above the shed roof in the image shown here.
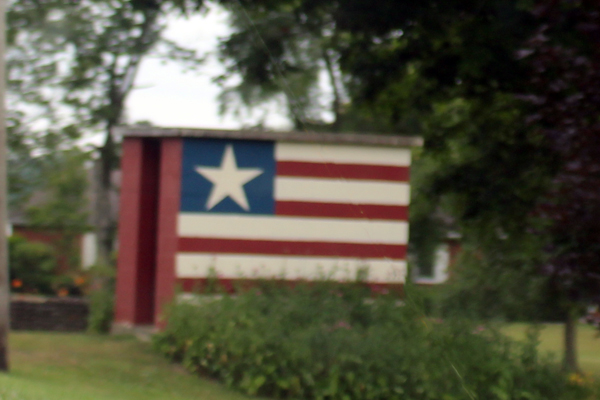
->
[127,7,290,129]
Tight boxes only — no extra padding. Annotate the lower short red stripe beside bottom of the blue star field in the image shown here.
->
[275,201,408,221]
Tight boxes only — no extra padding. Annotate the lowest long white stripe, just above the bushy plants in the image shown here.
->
[176,253,406,283]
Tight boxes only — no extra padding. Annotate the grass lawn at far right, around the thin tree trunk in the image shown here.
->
[503,324,600,377]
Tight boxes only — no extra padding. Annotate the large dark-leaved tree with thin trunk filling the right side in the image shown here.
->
[342,1,600,370]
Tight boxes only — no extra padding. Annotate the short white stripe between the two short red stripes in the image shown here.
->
[274,177,410,206]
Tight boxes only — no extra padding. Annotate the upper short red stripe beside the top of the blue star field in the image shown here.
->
[277,161,410,182]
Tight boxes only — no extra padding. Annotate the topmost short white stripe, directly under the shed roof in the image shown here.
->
[275,142,410,167]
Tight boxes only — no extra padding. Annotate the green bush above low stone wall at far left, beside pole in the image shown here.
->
[8,235,56,294]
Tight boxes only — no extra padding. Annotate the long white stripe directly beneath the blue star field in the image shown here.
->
[177,213,408,244]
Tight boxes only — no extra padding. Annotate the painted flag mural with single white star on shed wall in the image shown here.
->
[175,138,410,283]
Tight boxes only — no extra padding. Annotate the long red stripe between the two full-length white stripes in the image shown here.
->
[178,237,406,259]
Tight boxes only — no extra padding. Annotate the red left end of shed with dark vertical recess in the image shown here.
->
[115,138,160,327]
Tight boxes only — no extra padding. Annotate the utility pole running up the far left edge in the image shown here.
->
[0,0,10,372]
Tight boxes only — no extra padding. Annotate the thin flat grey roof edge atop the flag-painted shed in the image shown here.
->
[113,125,423,147]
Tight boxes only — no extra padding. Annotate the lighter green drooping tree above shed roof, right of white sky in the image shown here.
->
[217,1,347,131]
